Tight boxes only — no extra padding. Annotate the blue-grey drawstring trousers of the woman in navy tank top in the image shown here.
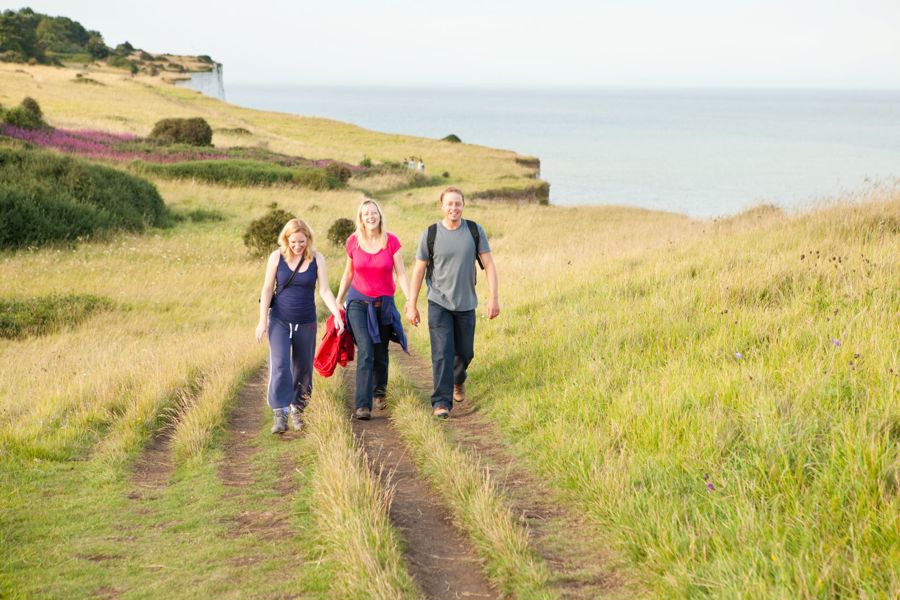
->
[268,316,316,409]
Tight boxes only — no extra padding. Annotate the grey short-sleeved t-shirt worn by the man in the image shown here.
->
[416,219,491,310]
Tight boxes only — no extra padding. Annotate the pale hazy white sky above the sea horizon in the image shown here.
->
[7,0,900,89]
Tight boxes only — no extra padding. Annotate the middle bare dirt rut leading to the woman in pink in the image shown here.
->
[345,364,498,599]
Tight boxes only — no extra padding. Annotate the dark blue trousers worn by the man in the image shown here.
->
[428,302,475,410]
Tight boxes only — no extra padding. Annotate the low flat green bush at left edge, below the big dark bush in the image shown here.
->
[0,295,115,339]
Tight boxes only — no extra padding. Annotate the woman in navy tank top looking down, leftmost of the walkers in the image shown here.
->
[256,219,344,433]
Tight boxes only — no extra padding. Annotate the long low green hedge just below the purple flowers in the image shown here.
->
[132,160,343,190]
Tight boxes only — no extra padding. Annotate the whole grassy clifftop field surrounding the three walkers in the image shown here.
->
[0,64,900,598]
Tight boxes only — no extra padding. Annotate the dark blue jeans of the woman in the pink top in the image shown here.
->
[347,300,391,410]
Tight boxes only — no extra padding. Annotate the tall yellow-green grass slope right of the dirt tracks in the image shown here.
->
[400,189,900,597]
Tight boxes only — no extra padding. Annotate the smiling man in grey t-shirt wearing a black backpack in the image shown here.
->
[405,187,500,419]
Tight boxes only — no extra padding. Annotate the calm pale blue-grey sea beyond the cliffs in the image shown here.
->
[220,85,900,217]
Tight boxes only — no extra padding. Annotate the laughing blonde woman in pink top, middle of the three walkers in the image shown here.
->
[337,199,409,420]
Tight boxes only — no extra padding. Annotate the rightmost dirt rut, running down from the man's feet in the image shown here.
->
[391,352,626,598]
